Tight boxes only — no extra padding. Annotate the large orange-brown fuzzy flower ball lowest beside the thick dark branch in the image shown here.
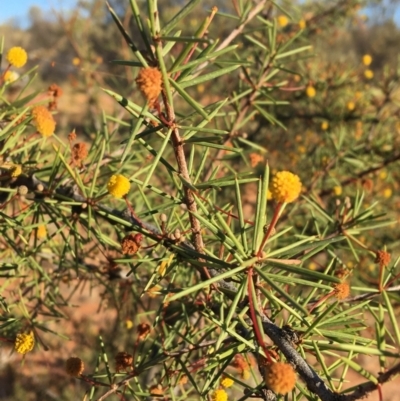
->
[265,362,296,395]
